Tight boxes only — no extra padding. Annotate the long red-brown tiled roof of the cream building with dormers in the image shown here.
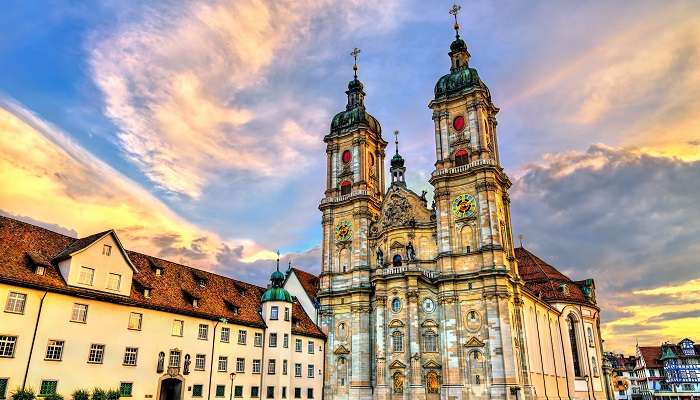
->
[0,216,324,338]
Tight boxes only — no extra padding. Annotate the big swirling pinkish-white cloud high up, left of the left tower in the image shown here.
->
[90,0,397,199]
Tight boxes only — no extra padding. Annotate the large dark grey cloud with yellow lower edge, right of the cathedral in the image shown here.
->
[511,144,700,350]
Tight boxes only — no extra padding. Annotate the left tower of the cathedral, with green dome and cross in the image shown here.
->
[318,49,387,398]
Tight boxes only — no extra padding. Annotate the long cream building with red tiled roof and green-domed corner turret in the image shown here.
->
[0,217,325,400]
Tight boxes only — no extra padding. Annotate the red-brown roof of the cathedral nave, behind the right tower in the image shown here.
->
[515,247,591,303]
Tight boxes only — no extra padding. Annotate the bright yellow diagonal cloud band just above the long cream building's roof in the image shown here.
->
[0,99,320,284]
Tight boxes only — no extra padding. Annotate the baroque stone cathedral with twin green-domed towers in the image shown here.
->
[317,6,606,400]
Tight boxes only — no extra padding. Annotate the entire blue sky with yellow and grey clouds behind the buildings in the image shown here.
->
[0,0,700,353]
